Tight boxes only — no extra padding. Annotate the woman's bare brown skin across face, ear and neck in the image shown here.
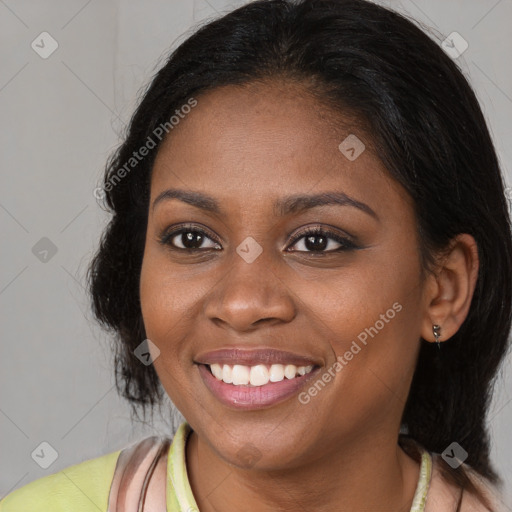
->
[140,82,478,512]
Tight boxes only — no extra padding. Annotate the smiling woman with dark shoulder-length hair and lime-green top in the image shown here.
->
[1,0,512,512]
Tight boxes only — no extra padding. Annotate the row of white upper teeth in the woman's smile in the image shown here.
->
[206,363,313,386]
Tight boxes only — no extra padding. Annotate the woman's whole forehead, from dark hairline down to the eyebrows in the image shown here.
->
[151,83,403,216]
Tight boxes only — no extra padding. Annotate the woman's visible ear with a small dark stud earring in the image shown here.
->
[421,233,479,342]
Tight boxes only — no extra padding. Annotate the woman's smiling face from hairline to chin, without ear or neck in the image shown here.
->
[140,84,425,468]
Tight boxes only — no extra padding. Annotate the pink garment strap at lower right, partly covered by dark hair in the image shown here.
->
[425,454,506,512]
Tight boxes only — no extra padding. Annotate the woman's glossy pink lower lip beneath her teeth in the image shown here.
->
[198,364,320,409]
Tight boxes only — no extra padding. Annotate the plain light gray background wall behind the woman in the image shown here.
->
[0,0,512,510]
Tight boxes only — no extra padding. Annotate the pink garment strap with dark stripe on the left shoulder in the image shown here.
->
[107,436,170,512]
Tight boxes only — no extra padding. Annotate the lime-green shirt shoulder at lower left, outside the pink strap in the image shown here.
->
[0,450,121,512]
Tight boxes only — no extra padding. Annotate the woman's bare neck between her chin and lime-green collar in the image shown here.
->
[186,426,419,512]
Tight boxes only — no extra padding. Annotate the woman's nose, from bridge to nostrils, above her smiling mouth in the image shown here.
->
[205,252,296,332]
